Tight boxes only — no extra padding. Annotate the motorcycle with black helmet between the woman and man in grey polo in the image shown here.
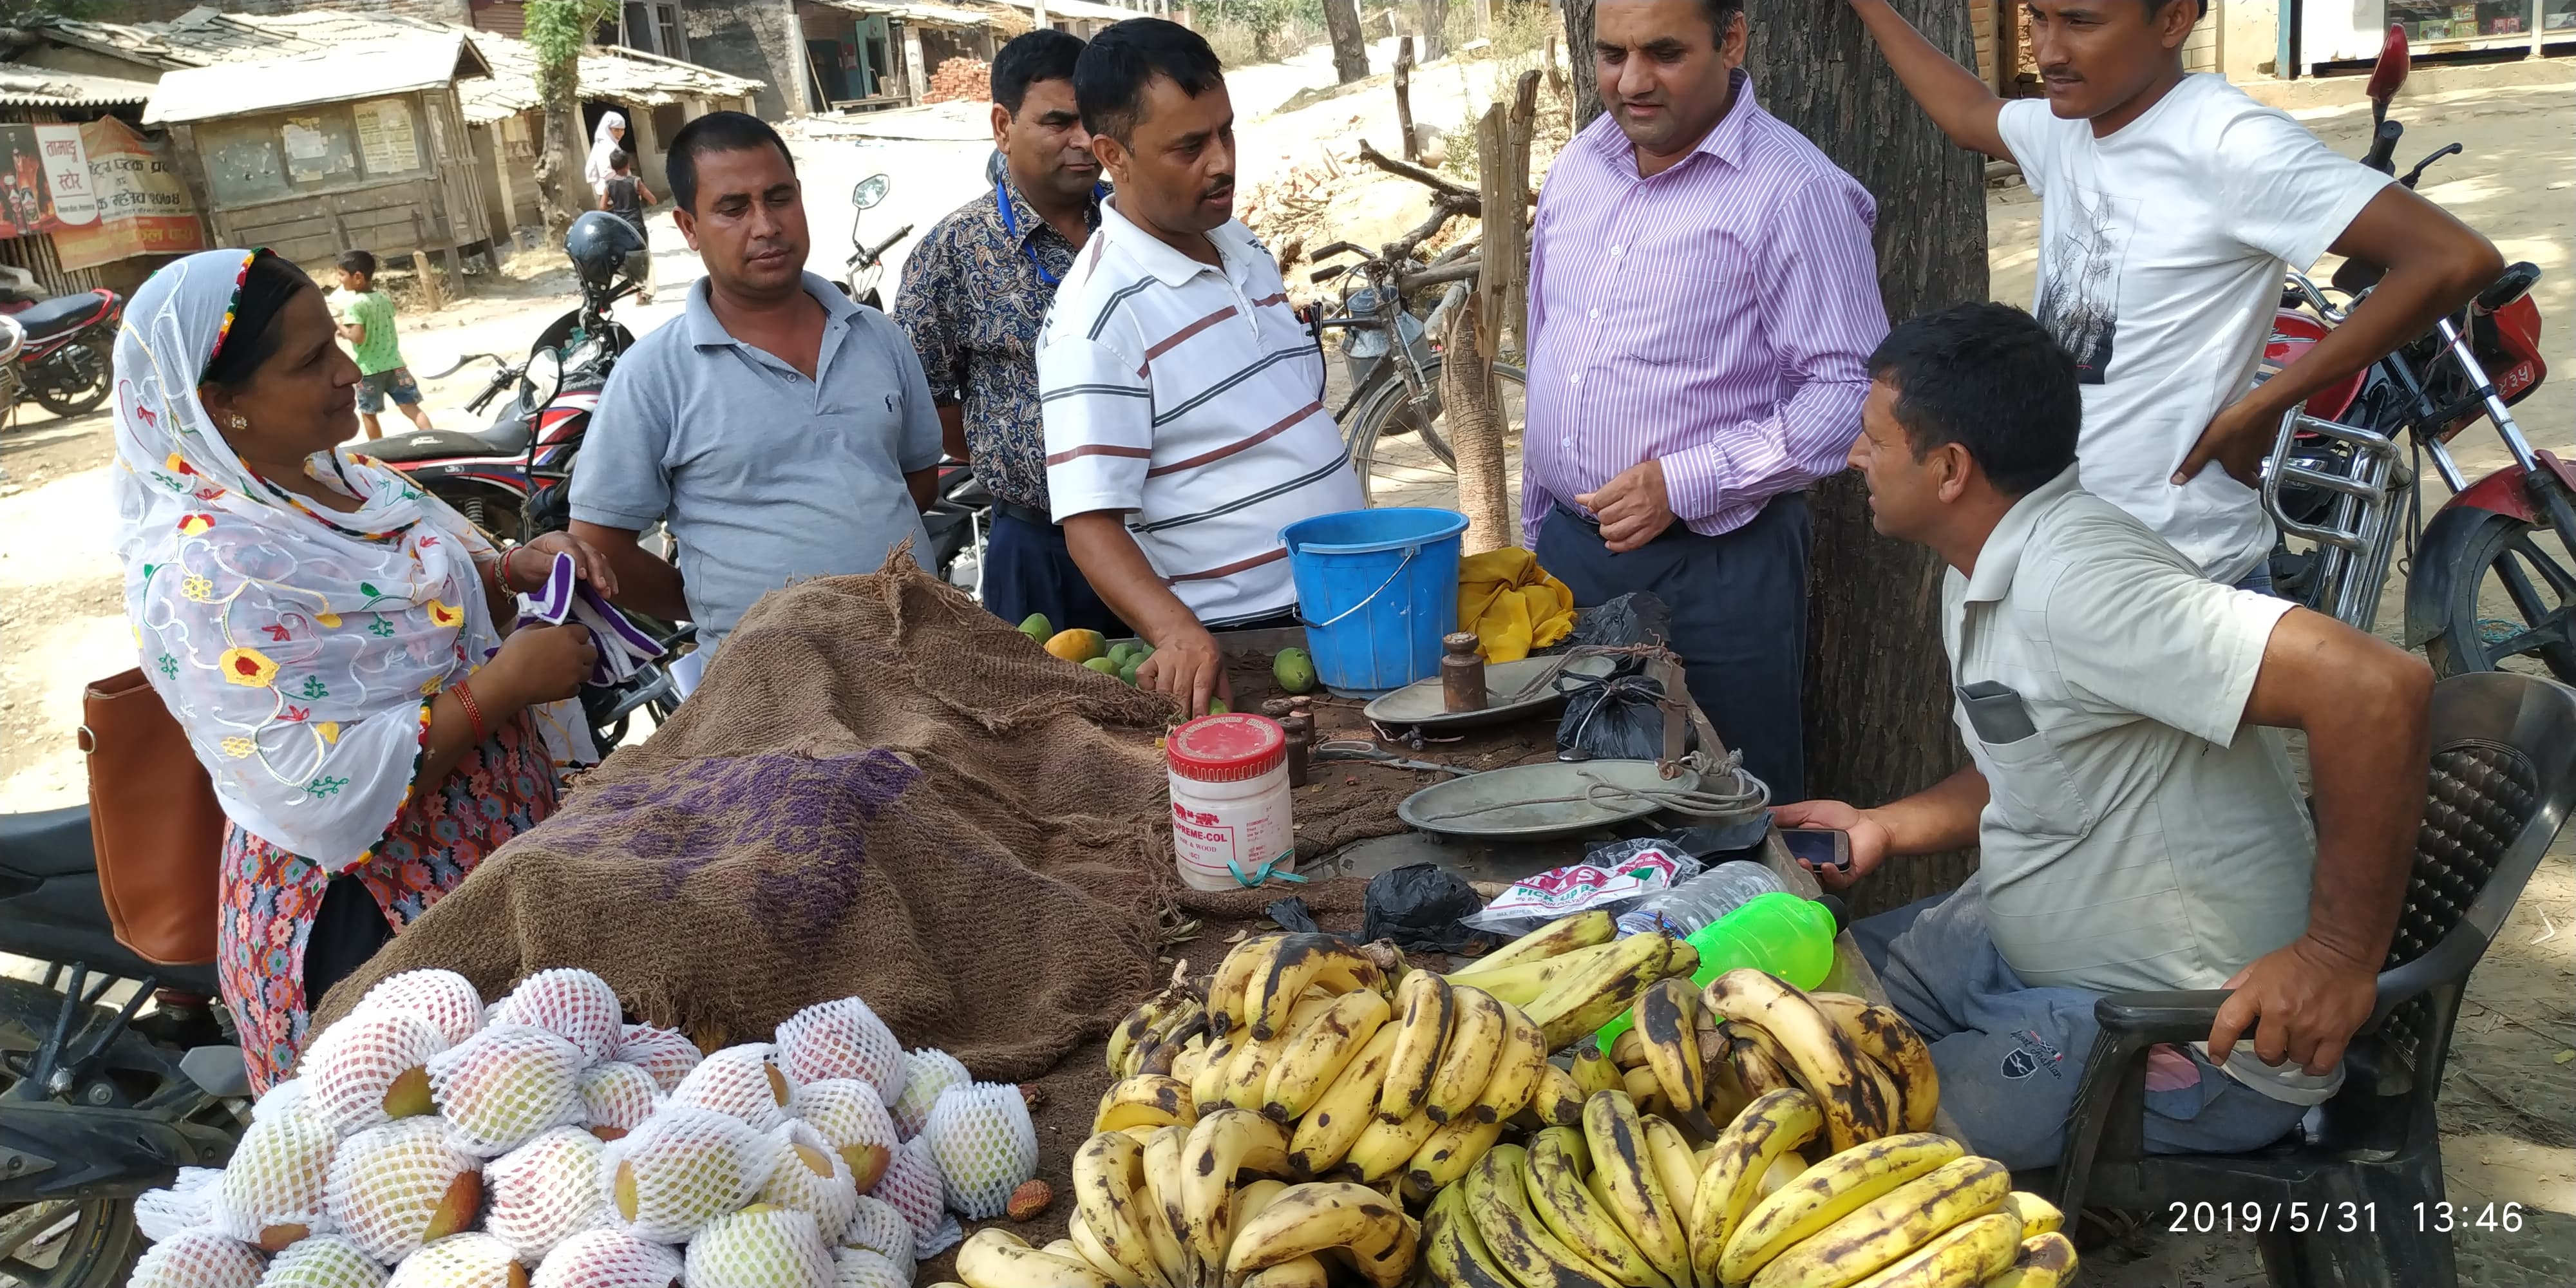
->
[368,211,696,752]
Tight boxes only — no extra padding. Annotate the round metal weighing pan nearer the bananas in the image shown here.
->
[1396,760,1700,840]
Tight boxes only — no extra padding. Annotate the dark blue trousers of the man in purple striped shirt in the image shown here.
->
[1538,492,1808,801]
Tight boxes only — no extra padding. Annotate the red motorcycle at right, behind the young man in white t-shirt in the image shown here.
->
[2257,26,2576,683]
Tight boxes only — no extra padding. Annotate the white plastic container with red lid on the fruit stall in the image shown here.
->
[1164,714,1296,891]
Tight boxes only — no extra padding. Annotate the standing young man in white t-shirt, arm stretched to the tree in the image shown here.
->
[1850,0,2504,590]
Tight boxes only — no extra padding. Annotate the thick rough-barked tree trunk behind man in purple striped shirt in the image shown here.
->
[1741,0,1986,914]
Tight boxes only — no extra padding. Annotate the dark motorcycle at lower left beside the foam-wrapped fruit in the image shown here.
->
[0,806,250,1288]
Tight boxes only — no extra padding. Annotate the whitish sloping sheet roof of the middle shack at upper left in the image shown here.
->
[144,31,489,126]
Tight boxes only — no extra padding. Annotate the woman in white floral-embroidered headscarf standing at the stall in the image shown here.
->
[113,250,611,1090]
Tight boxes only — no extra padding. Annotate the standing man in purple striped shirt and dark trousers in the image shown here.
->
[1520,0,1888,801]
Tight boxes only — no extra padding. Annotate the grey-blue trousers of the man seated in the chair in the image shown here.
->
[1852,876,2308,1170]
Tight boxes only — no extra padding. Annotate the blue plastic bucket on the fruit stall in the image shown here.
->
[1280,507,1466,698]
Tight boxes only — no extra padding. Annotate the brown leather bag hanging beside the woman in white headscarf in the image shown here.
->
[80,667,229,966]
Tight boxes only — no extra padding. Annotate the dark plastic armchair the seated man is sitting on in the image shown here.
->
[2022,672,2576,1288]
